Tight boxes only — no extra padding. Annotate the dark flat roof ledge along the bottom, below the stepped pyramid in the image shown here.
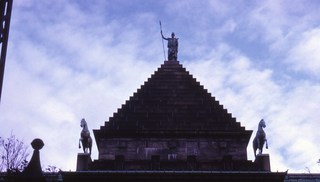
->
[62,171,286,182]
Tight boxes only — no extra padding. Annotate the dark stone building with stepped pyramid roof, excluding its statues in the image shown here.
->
[62,61,286,181]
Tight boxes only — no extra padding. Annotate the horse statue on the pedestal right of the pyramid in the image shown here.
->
[253,119,268,157]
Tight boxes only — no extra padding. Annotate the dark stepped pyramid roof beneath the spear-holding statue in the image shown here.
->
[94,61,252,140]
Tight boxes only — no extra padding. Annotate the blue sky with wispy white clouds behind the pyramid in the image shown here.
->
[0,0,320,173]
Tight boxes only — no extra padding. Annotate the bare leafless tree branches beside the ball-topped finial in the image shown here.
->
[0,133,29,172]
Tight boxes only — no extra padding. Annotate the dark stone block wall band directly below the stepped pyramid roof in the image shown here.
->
[98,138,247,161]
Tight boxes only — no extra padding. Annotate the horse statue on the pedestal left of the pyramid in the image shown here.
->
[79,118,92,154]
